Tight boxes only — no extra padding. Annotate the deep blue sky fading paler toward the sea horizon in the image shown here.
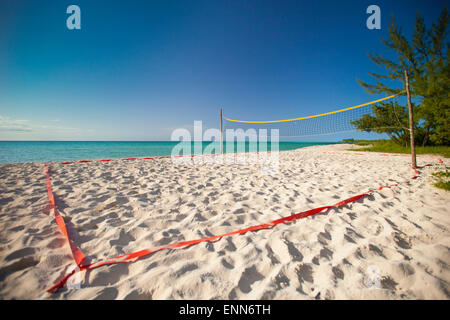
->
[0,0,445,141]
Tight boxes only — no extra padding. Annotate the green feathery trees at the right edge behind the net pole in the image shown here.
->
[355,7,450,146]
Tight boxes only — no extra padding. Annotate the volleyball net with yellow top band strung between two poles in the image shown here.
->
[223,93,408,138]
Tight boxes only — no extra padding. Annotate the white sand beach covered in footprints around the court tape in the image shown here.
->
[0,144,450,299]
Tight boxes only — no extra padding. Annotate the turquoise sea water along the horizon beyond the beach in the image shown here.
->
[0,141,333,163]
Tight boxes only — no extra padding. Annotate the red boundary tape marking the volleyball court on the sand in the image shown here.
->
[45,155,442,293]
